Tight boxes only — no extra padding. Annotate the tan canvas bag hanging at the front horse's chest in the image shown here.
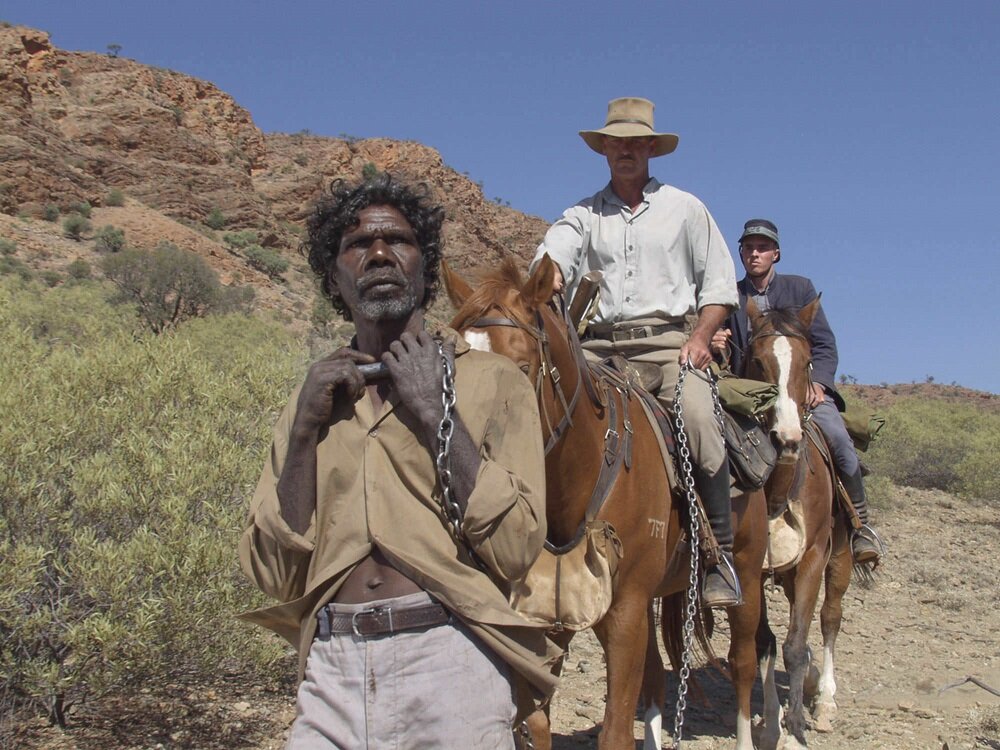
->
[510,520,622,631]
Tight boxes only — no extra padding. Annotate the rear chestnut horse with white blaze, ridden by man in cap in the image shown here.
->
[747,298,852,748]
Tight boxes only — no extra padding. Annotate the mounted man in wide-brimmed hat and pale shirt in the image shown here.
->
[532,97,742,607]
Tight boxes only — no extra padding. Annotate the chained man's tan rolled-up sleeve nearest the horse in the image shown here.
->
[462,363,546,581]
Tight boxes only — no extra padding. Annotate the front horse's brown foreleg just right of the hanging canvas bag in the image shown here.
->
[594,591,649,750]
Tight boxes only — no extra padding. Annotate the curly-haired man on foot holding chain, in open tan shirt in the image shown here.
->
[240,174,558,750]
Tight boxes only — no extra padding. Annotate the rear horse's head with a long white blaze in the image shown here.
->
[747,297,819,457]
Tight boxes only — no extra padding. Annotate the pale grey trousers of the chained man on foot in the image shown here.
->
[286,593,515,750]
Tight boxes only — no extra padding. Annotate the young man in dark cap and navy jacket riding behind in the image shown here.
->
[712,219,882,564]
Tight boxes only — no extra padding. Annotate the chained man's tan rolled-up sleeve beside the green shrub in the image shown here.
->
[239,398,316,602]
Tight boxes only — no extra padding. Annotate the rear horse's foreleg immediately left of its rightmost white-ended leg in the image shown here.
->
[782,539,827,748]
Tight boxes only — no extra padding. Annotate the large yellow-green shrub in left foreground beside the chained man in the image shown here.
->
[0,278,301,723]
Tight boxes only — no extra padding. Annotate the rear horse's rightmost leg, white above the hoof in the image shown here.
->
[813,522,853,732]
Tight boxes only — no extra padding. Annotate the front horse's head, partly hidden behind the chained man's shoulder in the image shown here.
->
[441,256,559,384]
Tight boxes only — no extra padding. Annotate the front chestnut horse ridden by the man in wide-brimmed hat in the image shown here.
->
[450,257,767,750]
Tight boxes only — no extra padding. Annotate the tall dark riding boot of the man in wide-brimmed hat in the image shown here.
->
[694,461,743,608]
